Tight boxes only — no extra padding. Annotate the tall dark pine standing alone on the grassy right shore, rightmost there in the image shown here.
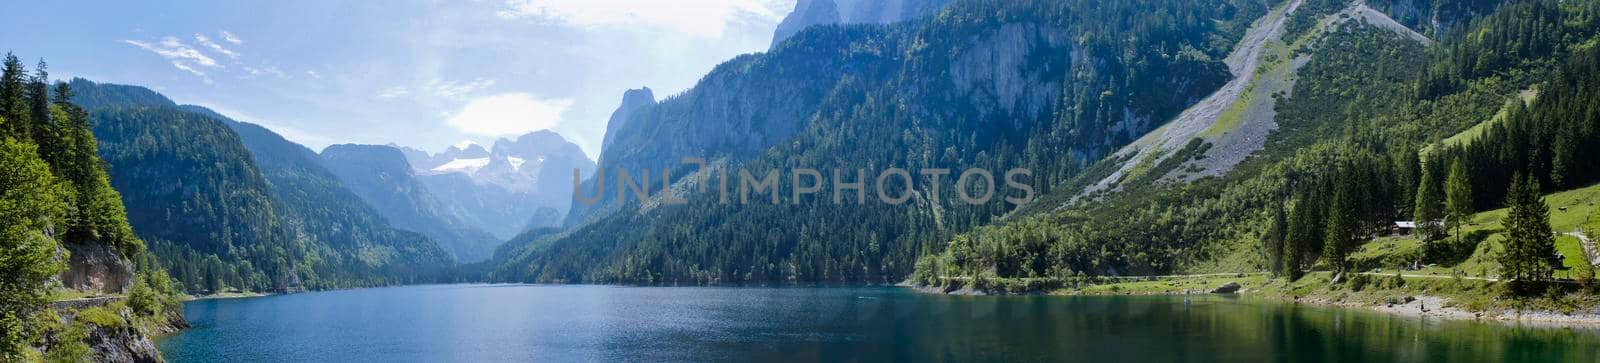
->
[1499,173,1555,281]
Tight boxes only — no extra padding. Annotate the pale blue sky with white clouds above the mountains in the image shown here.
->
[0,0,795,158]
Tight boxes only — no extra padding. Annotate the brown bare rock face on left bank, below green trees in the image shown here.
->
[61,243,133,294]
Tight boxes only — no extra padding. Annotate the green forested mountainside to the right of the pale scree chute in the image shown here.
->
[912,0,1600,289]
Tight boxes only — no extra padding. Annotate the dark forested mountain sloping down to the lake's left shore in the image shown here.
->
[70,80,453,291]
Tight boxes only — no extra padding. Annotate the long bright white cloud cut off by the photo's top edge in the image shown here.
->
[494,0,789,38]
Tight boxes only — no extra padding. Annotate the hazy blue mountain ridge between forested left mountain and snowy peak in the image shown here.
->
[322,144,501,262]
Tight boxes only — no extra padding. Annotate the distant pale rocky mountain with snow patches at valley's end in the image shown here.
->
[402,130,595,238]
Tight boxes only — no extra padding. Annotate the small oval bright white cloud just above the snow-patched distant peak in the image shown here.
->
[445,93,573,138]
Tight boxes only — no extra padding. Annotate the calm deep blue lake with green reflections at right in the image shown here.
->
[158,285,1600,361]
